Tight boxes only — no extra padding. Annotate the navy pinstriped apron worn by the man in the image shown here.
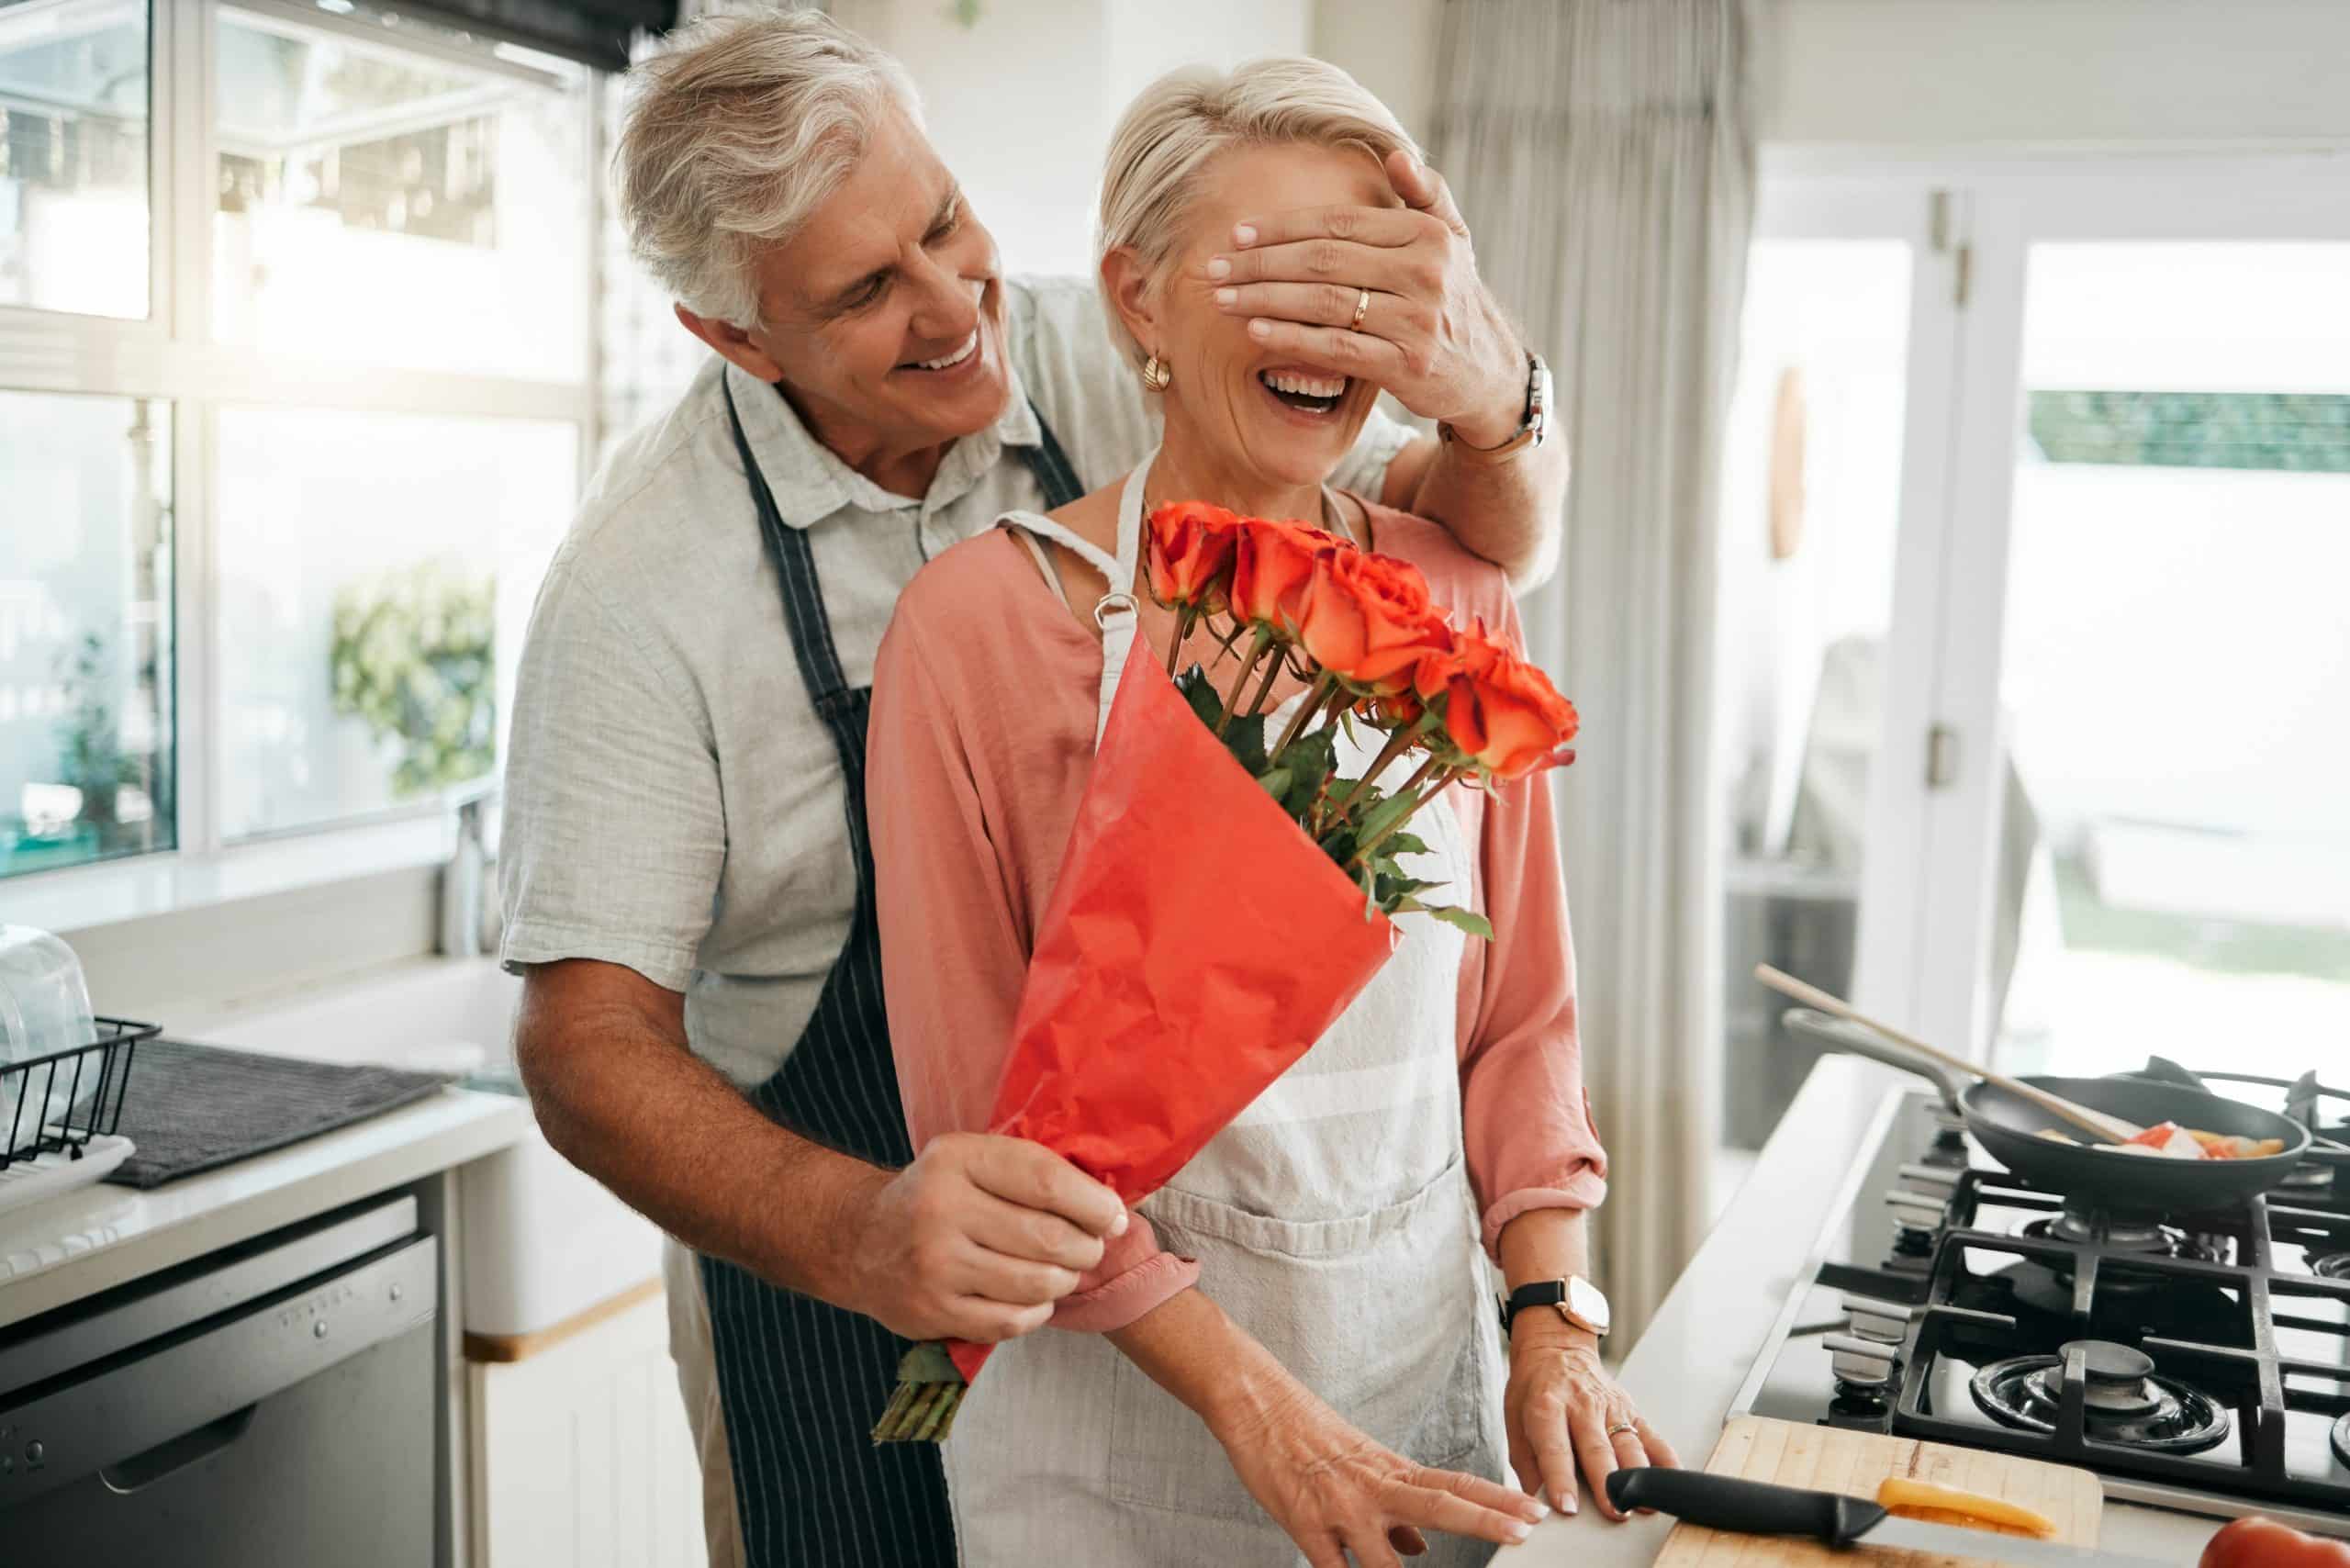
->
[698,388,1081,1568]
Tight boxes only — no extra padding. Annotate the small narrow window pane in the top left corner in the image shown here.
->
[0,0,148,318]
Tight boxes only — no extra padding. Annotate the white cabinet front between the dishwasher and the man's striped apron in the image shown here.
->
[465,1288,708,1568]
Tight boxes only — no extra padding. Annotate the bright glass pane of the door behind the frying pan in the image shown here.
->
[1998,240,2350,1077]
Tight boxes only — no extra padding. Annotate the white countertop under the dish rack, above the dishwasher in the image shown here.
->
[0,1089,532,1328]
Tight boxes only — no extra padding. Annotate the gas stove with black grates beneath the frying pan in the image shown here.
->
[1734,1074,2350,1535]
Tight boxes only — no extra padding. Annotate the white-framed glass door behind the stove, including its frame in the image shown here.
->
[1915,162,2350,1081]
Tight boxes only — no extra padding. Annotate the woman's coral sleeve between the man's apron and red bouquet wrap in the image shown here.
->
[865,606,1199,1333]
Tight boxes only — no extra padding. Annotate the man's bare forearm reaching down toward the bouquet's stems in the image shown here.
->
[517,973,890,1309]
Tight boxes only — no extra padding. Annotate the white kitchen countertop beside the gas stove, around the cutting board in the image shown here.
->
[1494,1056,2221,1568]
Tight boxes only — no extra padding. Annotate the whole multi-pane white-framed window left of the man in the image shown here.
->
[0,0,597,877]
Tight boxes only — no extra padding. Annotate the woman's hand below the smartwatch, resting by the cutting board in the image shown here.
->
[1502,1312,1680,1518]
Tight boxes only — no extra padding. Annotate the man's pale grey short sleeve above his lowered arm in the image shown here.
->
[498,559,726,992]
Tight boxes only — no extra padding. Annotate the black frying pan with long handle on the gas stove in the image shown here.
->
[1786,1006,2310,1213]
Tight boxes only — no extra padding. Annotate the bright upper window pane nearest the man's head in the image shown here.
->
[211,9,590,381]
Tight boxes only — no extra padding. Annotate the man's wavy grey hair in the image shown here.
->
[613,9,922,330]
